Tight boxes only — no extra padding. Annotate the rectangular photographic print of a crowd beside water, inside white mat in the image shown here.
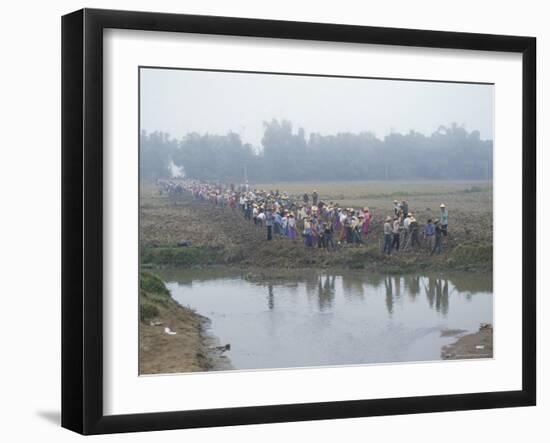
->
[138,67,496,375]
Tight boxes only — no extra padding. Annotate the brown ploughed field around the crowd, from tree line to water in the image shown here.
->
[140,181,493,272]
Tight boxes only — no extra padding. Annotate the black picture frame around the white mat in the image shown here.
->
[62,9,536,434]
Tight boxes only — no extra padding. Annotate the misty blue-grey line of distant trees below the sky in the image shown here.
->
[140,119,493,183]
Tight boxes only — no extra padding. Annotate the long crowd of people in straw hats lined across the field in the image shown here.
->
[157,180,449,255]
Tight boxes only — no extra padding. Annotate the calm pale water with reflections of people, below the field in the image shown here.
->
[159,270,493,369]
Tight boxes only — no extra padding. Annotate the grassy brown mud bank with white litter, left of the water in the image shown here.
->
[139,272,230,374]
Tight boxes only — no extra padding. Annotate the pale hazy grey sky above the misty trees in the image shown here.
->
[141,69,494,147]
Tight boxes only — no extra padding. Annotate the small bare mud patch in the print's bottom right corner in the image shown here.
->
[441,324,493,360]
